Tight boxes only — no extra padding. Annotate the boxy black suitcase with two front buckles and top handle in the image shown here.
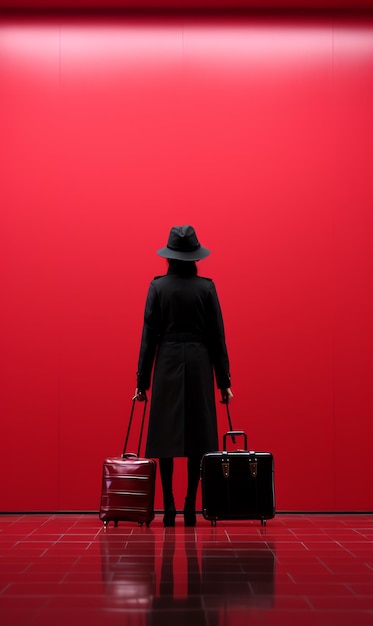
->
[201,430,275,525]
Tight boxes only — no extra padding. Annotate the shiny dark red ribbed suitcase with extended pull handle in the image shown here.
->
[99,397,157,528]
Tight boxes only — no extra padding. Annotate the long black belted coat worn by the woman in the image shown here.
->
[137,270,231,458]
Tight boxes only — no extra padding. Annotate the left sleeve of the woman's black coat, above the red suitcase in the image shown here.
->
[137,281,159,391]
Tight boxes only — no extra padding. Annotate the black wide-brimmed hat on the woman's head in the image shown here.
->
[157,224,210,261]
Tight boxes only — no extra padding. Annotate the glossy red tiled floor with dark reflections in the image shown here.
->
[0,514,373,626]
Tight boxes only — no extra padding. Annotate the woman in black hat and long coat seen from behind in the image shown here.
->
[135,225,233,526]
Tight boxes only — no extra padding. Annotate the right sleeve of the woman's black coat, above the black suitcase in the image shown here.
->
[209,281,231,389]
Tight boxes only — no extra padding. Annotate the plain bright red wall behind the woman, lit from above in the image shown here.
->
[0,16,373,511]
